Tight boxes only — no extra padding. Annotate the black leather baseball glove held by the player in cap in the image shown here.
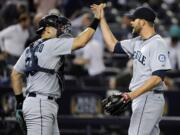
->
[102,93,131,115]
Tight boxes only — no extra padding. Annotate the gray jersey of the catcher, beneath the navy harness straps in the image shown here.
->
[14,38,73,97]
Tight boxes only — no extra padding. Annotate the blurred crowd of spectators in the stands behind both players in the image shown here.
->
[0,0,180,116]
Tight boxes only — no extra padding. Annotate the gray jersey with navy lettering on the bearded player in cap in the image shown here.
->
[120,35,171,91]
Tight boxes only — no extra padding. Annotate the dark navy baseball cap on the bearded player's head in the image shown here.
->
[127,7,156,23]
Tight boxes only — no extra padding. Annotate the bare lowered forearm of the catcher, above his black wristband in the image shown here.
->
[11,70,23,95]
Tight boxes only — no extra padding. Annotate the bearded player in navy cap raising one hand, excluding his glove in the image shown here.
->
[91,4,171,135]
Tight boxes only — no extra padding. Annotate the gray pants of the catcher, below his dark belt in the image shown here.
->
[23,95,60,135]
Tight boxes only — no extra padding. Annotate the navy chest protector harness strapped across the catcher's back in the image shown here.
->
[25,40,65,90]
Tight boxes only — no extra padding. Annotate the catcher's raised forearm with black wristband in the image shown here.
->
[72,18,99,50]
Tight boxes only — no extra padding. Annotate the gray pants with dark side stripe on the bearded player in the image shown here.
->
[128,92,165,135]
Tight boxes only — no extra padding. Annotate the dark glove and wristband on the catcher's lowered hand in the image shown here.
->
[16,103,27,135]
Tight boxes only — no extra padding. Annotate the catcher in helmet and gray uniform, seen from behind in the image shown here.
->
[11,10,99,135]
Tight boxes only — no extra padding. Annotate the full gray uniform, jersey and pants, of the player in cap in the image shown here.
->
[114,35,171,135]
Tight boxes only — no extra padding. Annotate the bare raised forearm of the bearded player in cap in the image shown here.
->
[100,18,118,52]
